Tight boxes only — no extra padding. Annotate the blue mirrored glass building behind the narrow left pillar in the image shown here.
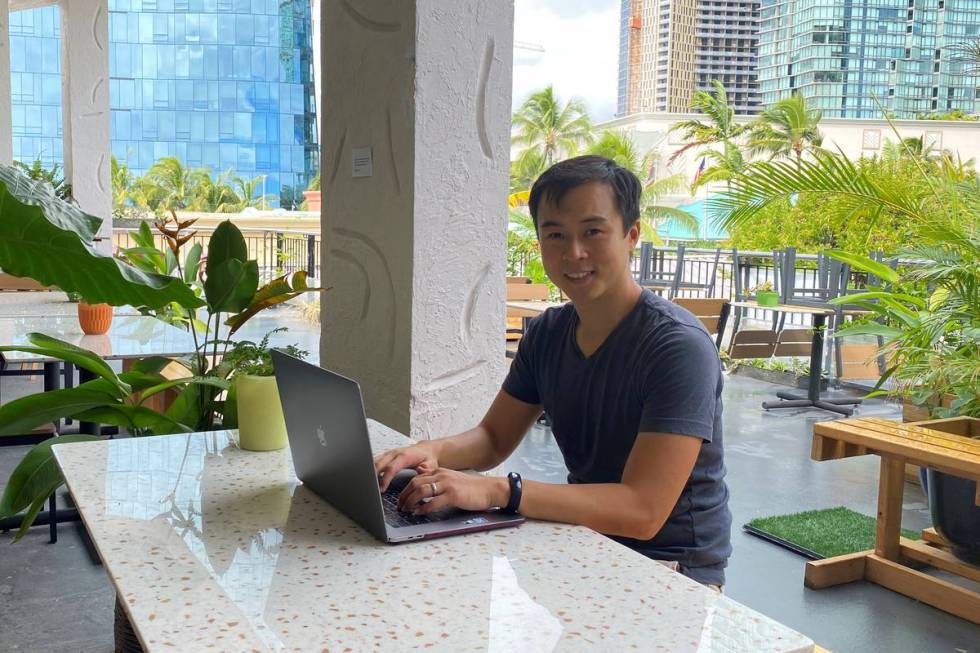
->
[10,0,319,205]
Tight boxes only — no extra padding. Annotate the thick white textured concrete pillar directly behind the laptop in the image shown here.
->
[320,0,514,438]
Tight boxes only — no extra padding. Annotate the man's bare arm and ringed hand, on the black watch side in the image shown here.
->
[410,433,702,540]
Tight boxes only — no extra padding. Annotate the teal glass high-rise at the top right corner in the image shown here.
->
[759,0,980,118]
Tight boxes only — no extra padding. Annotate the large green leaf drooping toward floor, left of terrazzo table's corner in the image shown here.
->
[0,435,100,542]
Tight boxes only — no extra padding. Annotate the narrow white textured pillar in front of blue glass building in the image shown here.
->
[59,0,112,243]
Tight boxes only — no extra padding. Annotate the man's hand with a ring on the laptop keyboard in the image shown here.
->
[398,469,510,515]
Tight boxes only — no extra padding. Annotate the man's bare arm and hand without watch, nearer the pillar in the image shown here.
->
[374,390,541,492]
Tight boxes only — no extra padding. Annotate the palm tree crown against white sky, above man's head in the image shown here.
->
[511,86,592,168]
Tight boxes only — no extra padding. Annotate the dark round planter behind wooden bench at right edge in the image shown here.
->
[926,469,980,565]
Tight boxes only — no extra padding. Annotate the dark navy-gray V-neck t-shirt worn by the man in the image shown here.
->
[503,290,732,585]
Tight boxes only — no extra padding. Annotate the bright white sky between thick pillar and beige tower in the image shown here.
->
[513,0,620,122]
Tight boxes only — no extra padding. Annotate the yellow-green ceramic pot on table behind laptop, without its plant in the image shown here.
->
[235,375,286,451]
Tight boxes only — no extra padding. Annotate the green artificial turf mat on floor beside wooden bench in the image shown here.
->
[742,506,921,560]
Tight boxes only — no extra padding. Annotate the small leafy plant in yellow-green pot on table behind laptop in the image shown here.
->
[223,327,309,451]
